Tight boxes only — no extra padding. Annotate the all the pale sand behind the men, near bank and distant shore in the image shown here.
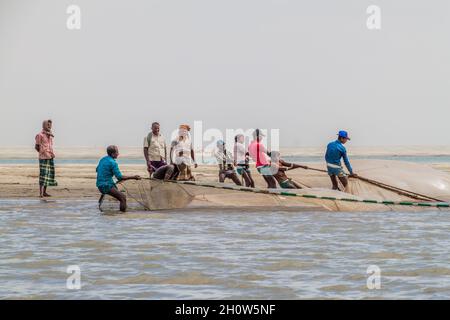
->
[0,147,450,199]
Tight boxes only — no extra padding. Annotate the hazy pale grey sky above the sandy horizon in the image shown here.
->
[0,0,450,146]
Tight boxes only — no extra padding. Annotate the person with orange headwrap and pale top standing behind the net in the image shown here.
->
[170,124,198,181]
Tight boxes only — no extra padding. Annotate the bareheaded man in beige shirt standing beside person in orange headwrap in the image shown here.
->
[144,122,167,177]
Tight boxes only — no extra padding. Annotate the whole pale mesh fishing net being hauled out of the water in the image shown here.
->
[112,160,450,212]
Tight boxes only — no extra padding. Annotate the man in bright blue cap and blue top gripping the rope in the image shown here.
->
[325,131,356,190]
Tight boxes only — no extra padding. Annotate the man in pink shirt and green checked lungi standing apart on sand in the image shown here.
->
[34,120,58,198]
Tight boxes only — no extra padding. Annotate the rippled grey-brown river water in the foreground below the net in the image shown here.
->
[0,200,450,299]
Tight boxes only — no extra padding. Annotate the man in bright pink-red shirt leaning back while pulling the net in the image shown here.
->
[248,129,277,189]
